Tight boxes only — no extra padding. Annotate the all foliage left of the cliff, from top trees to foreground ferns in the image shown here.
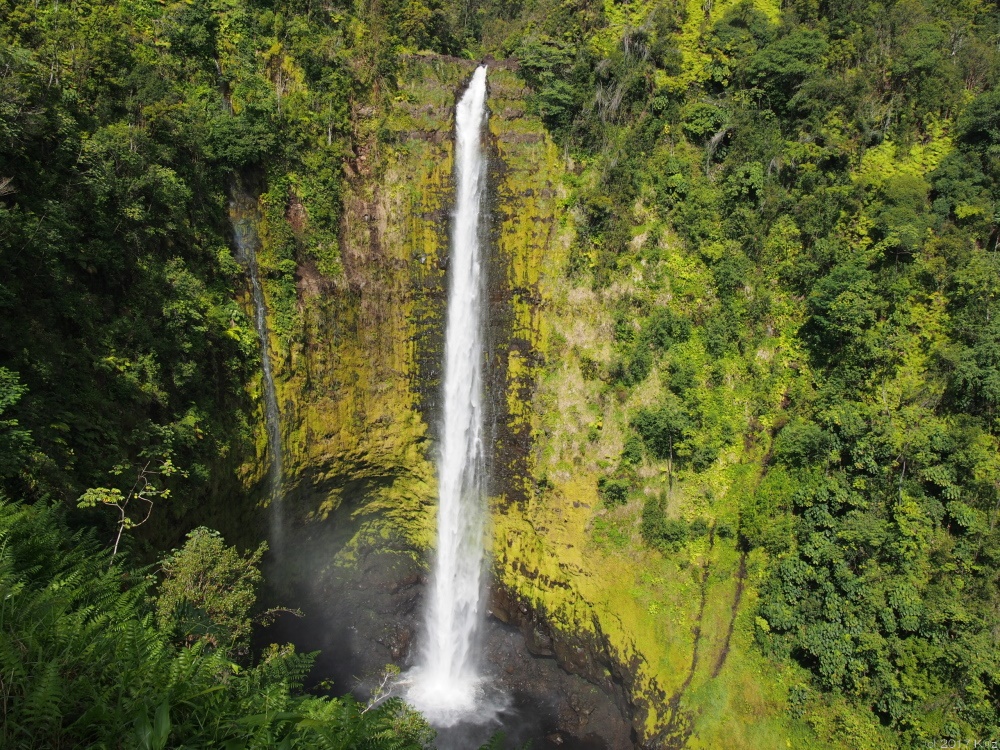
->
[0,0,456,748]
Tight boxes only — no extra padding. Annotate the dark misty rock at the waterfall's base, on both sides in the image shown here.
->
[255,516,616,750]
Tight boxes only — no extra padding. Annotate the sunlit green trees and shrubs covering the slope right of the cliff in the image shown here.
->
[483,0,1000,747]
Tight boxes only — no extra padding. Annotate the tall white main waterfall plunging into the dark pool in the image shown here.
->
[407,66,486,726]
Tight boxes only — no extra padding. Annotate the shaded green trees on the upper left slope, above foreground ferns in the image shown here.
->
[0,0,476,524]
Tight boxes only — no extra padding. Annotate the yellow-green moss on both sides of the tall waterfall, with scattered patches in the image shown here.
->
[236,54,832,748]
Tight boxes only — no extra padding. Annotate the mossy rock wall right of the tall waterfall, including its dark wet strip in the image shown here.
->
[480,64,822,749]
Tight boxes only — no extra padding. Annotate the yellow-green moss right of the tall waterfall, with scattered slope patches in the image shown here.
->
[480,72,819,748]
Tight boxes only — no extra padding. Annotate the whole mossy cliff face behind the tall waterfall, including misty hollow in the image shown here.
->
[246,57,800,747]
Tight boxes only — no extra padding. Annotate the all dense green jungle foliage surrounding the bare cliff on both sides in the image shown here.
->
[0,0,1000,747]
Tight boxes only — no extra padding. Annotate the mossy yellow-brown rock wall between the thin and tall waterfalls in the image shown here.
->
[252,62,474,555]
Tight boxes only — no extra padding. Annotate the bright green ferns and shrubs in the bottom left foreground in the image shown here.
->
[0,503,430,750]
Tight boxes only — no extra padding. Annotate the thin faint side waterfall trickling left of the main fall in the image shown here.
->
[230,197,284,553]
